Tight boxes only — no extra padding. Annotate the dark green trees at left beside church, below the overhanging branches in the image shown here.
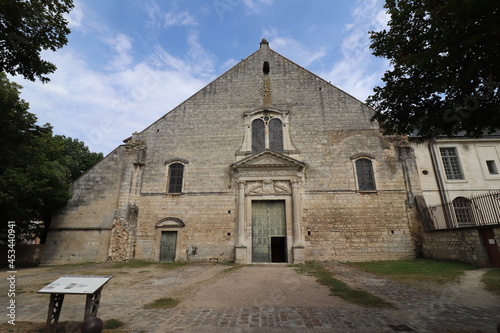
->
[0,73,102,241]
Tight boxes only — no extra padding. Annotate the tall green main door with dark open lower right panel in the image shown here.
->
[252,200,287,262]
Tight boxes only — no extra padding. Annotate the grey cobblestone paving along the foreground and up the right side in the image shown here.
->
[119,264,500,333]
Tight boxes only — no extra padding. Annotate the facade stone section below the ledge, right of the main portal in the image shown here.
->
[304,192,415,261]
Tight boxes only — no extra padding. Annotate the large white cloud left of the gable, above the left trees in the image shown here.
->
[13,35,213,153]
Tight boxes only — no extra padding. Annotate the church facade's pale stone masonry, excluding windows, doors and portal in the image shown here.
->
[44,41,426,261]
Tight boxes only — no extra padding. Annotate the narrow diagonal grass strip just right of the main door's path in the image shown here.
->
[295,261,396,309]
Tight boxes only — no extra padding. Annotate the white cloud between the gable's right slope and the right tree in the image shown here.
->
[321,0,389,100]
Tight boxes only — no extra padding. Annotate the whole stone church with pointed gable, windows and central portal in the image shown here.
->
[42,39,421,264]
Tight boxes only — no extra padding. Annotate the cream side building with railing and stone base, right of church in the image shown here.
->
[410,133,500,267]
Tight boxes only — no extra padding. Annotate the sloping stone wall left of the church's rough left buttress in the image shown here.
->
[42,147,124,264]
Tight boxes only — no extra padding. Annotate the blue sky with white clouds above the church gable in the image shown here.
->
[11,0,389,155]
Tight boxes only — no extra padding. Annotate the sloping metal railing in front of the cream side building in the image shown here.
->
[422,191,500,230]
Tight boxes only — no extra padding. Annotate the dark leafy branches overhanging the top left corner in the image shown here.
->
[0,0,73,83]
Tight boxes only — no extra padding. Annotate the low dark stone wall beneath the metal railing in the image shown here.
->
[422,228,492,266]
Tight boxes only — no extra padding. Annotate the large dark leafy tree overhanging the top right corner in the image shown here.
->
[367,0,500,138]
